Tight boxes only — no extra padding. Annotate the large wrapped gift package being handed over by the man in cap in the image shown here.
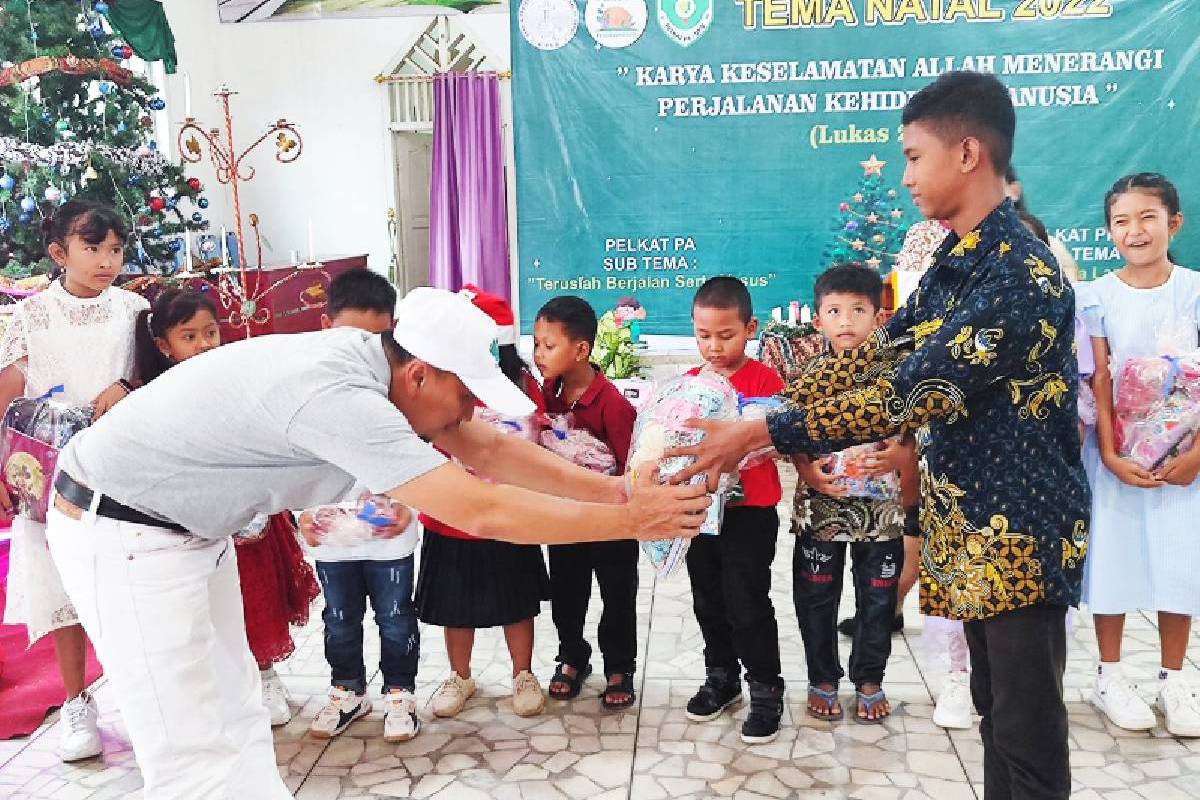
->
[629,371,738,577]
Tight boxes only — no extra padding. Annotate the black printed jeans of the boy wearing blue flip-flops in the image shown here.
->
[792,536,904,687]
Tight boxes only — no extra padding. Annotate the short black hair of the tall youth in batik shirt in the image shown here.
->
[900,71,1016,175]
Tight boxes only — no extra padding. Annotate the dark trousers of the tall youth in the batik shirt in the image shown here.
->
[964,603,1070,800]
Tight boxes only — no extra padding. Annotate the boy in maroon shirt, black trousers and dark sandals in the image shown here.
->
[533,297,638,710]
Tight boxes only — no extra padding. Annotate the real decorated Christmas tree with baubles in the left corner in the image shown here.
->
[0,0,201,277]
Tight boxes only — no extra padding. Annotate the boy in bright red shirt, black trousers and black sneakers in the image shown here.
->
[688,277,784,744]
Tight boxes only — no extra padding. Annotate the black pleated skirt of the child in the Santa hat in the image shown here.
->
[416,530,550,627]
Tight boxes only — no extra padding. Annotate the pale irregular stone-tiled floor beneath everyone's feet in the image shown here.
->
[0,465,1200,800]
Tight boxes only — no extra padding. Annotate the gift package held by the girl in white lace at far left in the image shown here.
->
[0,386,92,522]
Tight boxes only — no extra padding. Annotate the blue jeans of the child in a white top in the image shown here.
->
[317,555,421,694]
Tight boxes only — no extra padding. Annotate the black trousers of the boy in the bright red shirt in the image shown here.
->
[688,506,784,686]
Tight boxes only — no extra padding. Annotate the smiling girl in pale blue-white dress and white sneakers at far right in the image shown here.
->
[1078,173,1200,736]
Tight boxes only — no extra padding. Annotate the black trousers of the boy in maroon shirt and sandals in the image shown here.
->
[546,540,641,675]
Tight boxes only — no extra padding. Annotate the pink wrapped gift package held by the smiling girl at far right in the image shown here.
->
[1114,353,1200,469]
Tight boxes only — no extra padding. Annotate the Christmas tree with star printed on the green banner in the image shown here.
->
[822,154,908,275]
